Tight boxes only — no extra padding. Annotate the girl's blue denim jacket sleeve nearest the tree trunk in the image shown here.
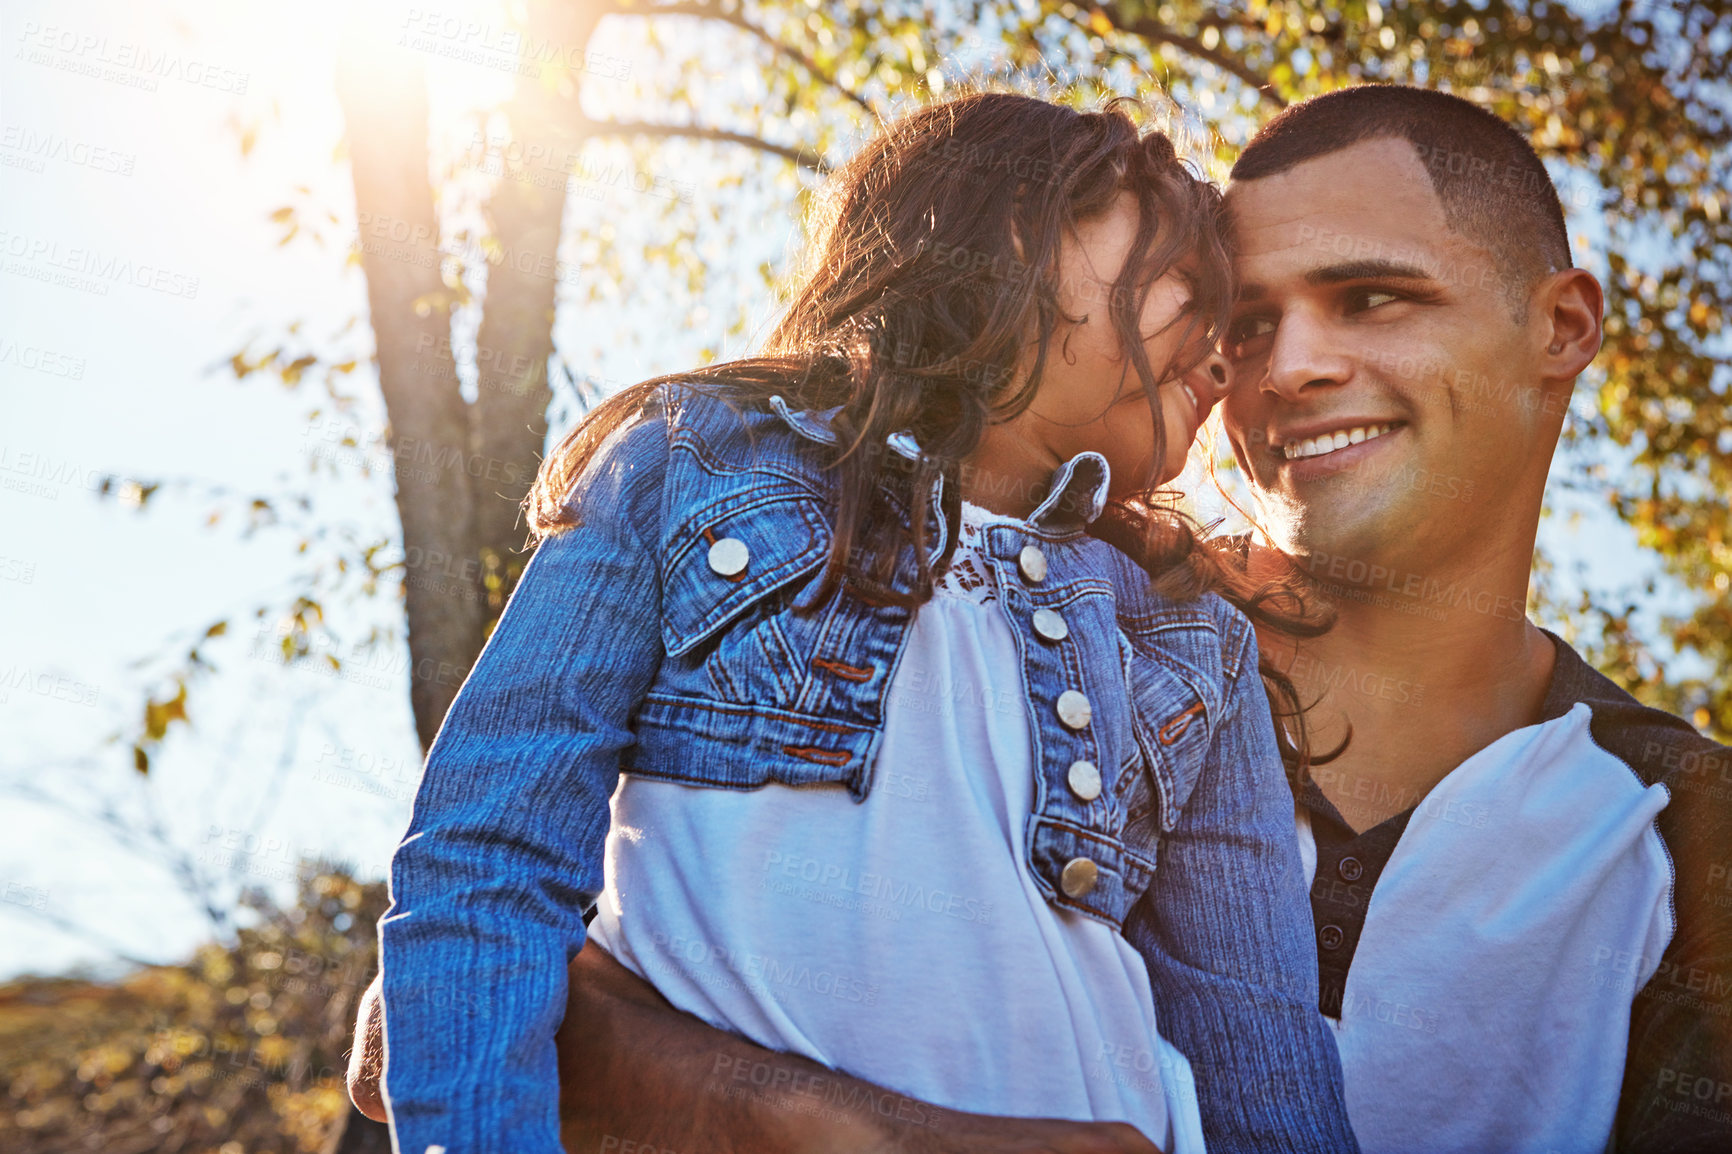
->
[379,407,667,1154]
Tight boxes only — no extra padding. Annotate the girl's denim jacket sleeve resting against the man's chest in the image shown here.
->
[1124,626,1358,1154]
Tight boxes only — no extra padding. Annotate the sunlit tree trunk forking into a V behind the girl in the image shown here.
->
[338,0,601,752]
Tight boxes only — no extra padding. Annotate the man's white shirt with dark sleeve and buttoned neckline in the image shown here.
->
[1297,636,1732,1154]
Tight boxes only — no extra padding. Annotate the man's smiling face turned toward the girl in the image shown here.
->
[1225,139,1567,563]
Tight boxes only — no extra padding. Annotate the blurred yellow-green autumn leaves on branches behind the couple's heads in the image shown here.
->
[101,0,1711,771]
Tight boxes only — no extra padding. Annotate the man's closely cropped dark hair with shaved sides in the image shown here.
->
[1231,85,1571,312]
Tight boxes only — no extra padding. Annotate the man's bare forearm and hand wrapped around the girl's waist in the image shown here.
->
[348,946,1160,1154]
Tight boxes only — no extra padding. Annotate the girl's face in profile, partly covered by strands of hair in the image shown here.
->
[1005,192,1231,497]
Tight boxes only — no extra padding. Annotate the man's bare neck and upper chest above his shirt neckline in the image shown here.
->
[1252,533,1555,830]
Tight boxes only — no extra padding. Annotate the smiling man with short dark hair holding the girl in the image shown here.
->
[357,87,1732,1154]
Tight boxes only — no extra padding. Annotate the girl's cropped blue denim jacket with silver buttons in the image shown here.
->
[379,386,1358,1154]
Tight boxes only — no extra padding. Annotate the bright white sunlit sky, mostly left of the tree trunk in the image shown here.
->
[0,0,1683,977]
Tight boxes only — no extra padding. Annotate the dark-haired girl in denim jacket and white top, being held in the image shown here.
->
[379,95,1354,1154]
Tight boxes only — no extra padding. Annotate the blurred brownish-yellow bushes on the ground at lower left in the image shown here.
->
[0,865,386,1154]
